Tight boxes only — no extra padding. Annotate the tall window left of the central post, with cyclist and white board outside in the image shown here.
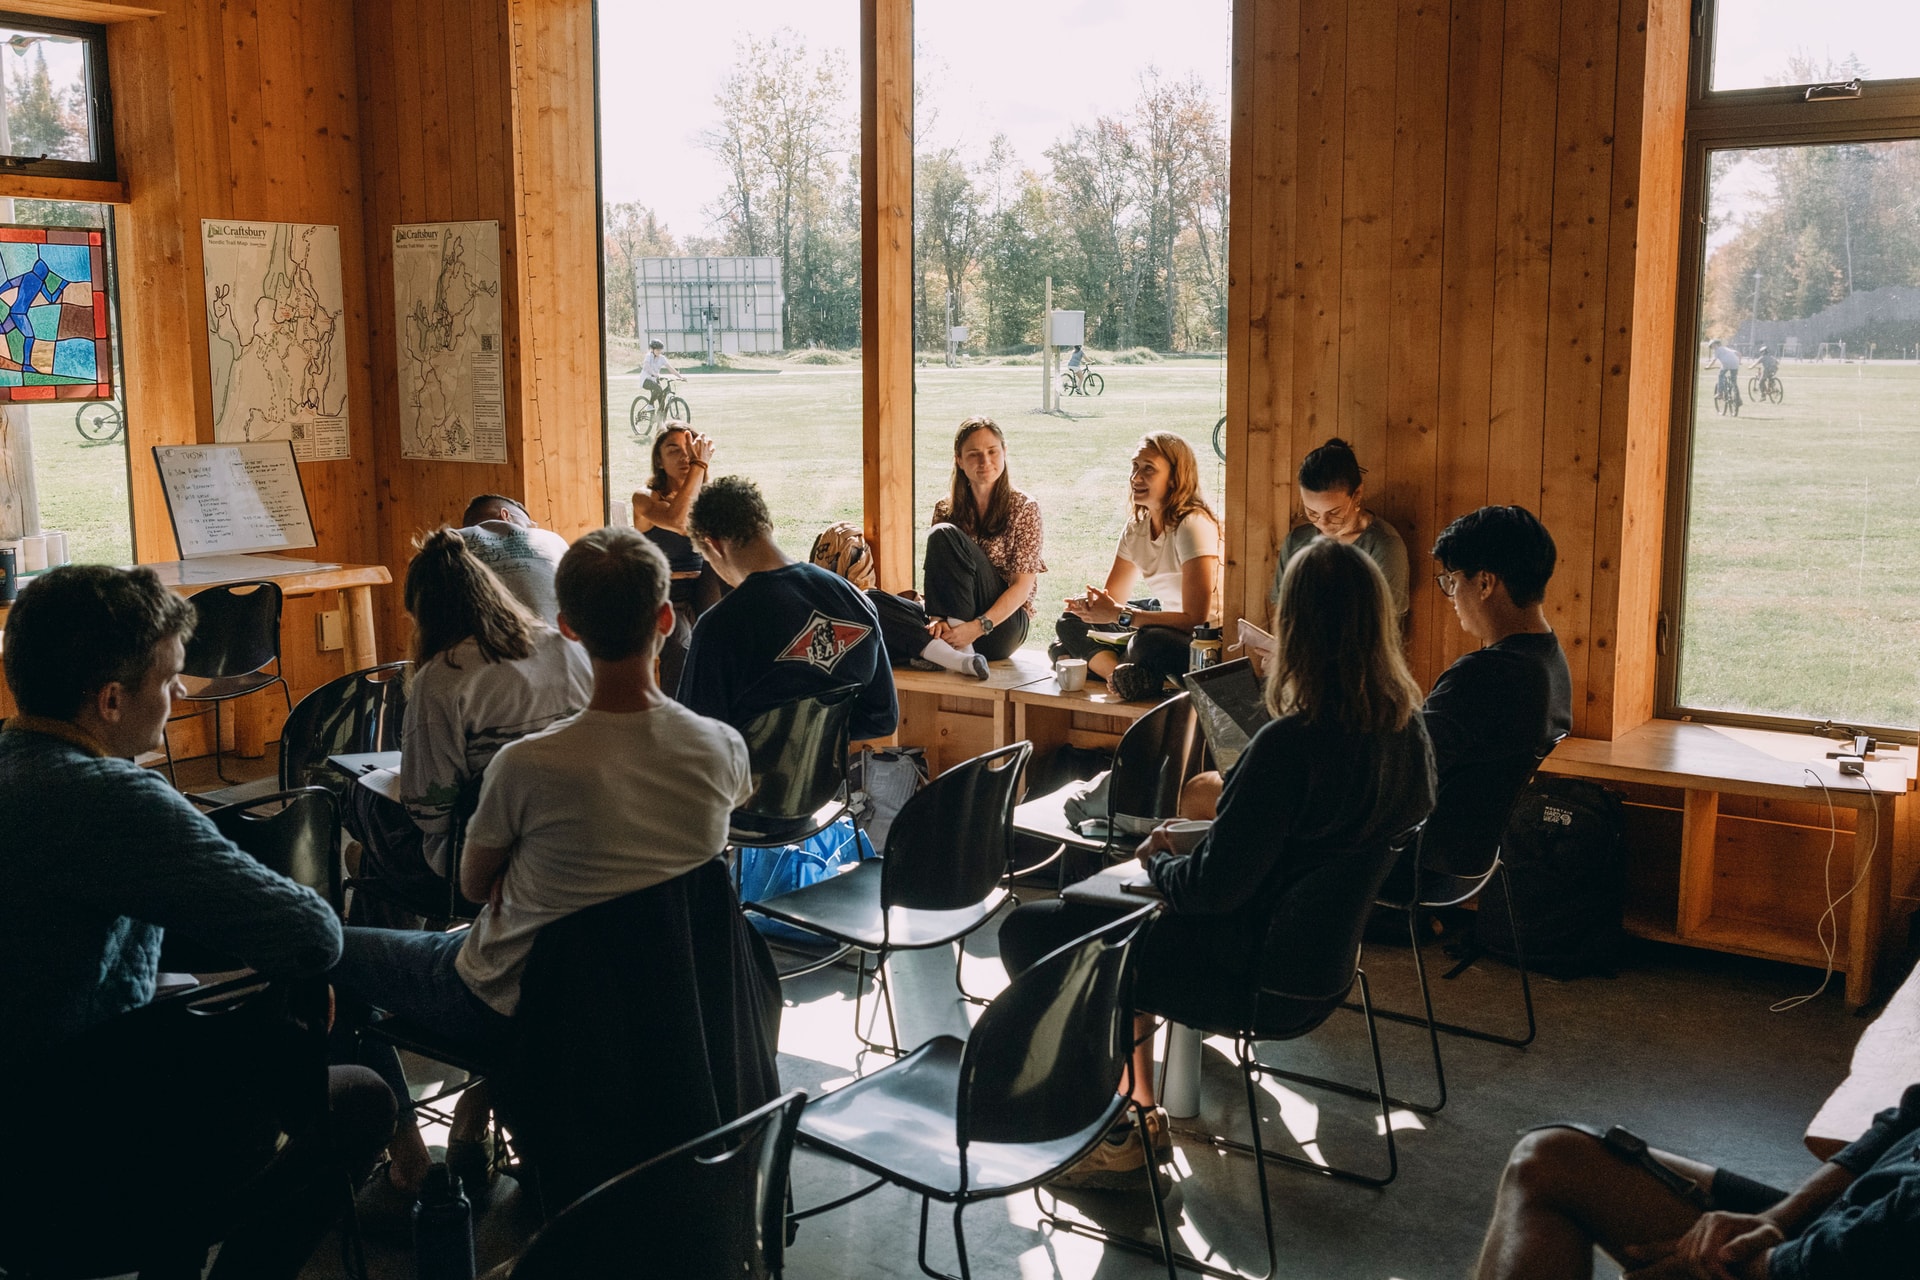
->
[597,0,862,557]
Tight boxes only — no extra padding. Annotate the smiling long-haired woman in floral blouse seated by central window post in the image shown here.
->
[922,418,1046,660]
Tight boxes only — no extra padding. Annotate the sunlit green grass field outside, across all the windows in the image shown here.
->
[31,361,1920,725]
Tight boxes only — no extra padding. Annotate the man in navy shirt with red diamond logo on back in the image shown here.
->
[676,476,900,739]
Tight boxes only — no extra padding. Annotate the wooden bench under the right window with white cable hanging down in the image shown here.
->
[1540,720,1914,1007]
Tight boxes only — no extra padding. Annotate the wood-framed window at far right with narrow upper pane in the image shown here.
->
[1663,0,1920,729]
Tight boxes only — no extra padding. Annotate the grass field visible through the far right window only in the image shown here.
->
[1678,363,1920,725]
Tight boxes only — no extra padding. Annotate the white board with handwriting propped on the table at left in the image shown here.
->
[154,439,315,560]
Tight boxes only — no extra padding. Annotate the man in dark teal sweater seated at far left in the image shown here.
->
[0,564,394,1280]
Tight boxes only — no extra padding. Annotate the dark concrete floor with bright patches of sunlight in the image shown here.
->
[168,762,1889,1280]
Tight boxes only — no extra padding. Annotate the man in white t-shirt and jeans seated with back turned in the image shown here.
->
[332,528,753,1203]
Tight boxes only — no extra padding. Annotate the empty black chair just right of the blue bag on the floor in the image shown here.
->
[747,743,1033,1054]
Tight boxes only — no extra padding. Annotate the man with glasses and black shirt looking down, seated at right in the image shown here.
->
[1423,507,1572,869]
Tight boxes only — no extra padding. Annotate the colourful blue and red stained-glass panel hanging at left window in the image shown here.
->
[0,226,113,403]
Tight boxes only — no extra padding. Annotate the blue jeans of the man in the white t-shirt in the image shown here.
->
[326,925,513,1113]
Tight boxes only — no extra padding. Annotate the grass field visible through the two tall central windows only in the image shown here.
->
[607,361,1225,645]
